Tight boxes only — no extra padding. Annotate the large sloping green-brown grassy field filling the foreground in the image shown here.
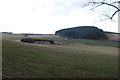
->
[2,35,118,78]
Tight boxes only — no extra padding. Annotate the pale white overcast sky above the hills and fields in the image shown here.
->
[0,0,118,34]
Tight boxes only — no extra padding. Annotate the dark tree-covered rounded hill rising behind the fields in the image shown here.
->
[55,26,107,40]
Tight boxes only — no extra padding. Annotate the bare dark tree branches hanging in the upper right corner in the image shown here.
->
[84,0,120,21]
